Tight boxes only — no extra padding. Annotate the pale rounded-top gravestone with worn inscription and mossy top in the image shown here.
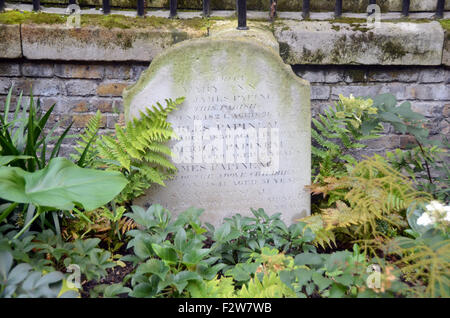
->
[124,21,311,226]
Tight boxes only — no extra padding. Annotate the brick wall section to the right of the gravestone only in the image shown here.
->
[293,65,450,154]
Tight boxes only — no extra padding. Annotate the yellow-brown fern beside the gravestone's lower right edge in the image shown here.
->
[310,155,431,250]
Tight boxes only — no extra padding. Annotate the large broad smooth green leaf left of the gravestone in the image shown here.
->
[0,158,128,211]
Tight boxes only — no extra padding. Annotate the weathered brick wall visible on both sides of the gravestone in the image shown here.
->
[0,59,450,158]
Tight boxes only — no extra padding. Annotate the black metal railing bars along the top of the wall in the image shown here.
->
[0,0,445,30]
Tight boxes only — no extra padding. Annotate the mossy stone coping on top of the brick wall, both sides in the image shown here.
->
[0,12,450,65]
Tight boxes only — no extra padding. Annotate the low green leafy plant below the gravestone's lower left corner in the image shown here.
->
[122,205,224,297]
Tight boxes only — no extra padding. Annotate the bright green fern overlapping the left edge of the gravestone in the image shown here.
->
[96,98,184,203]
